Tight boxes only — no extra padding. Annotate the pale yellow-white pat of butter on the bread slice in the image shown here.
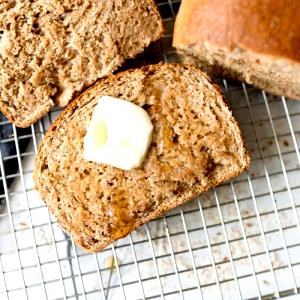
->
[83,96,153,170]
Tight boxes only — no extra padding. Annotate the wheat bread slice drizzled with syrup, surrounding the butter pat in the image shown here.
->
[34,64,250,252]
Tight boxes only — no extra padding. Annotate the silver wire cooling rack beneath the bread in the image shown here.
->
[0,0,300,299]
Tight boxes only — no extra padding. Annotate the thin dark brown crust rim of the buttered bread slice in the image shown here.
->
[33,62,250,253]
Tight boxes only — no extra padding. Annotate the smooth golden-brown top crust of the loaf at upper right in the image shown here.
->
[174,0,300,62]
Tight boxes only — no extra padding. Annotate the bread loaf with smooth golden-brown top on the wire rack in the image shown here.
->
[173,0,300,99]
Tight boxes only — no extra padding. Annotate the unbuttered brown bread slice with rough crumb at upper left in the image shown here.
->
[0,0,162,127]
